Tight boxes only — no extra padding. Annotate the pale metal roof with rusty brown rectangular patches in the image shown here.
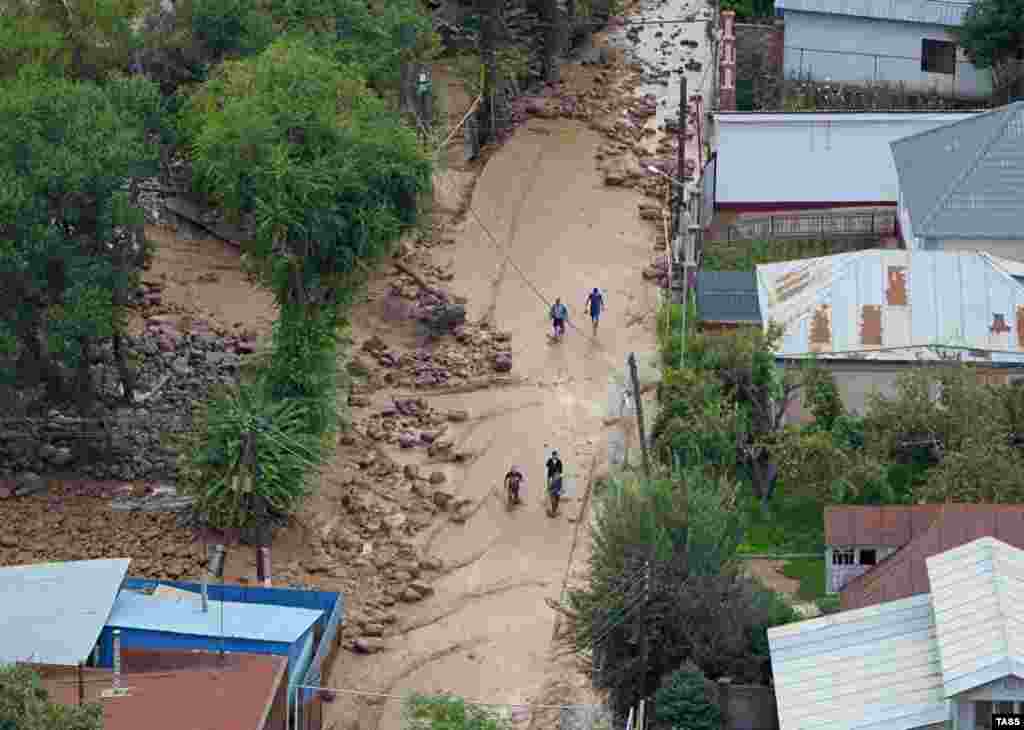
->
[757,250,1024,362]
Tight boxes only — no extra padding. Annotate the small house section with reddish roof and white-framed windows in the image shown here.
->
[825,505,942,594]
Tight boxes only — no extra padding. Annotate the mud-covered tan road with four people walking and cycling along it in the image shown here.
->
[325,119,657,729]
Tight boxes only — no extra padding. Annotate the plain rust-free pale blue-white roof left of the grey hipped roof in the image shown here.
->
[715,112,975,205]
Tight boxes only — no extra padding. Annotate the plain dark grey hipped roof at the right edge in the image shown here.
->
[891,101,1024,240]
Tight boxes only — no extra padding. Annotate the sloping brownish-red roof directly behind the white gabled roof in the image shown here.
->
[840,505,1024,609]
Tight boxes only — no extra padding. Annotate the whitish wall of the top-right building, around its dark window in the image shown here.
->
[783,10,992,98]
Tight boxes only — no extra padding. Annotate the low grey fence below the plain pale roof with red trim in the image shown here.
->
[726,207,896,242]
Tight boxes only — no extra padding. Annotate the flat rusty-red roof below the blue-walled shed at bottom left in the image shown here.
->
[42,649,288,730]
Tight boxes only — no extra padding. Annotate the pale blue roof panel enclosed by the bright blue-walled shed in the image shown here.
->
[106,591,323,644]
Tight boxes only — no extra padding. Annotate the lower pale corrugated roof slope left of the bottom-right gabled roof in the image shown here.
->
[768,596,947,730]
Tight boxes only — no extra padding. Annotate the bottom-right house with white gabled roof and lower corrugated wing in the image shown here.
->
[768,538,1024,730]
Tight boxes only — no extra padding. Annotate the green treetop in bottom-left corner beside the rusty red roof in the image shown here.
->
[0,664,103,730]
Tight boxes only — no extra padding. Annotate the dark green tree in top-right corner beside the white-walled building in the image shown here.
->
[955,0,1024,88]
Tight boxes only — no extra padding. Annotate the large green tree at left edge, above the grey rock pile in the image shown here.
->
[0,68,161,416]
